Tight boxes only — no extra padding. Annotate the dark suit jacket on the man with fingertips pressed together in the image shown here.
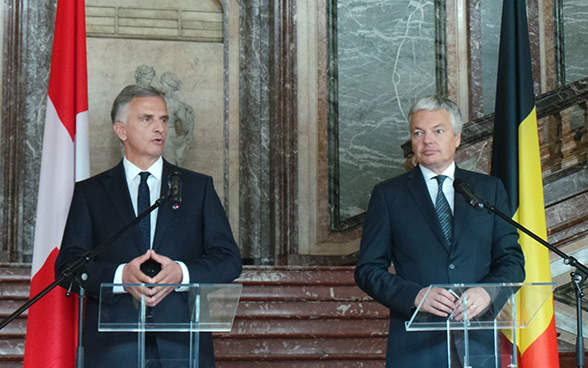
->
[55,160,242,367]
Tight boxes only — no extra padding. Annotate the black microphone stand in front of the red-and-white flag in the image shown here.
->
[0,193,174,368]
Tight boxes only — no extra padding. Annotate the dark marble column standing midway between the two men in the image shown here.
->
[239,0,298,264]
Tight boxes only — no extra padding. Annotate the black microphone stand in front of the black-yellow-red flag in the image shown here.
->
[474,199,588,368]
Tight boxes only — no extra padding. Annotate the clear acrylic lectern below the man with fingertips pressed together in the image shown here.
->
[98,284,242,368]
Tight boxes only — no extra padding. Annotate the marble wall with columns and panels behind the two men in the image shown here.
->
[0,0,588,264]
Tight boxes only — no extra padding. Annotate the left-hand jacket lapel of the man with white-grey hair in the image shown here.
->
[406,167,449,252]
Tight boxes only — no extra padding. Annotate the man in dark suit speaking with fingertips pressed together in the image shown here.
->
[55,85,242,368]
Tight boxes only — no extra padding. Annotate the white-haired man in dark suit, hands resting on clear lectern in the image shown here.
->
[355,96,525,368]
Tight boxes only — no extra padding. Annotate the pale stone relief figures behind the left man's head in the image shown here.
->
[135,65,195,166]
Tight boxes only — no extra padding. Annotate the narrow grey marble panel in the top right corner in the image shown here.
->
[560,0,588,83]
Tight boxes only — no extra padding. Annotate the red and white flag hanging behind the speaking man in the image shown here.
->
[24,0,90,368]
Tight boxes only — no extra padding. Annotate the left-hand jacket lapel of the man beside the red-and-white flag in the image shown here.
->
[104,161,143,253]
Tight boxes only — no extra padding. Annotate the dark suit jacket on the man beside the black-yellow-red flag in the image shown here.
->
[355,167,525,368]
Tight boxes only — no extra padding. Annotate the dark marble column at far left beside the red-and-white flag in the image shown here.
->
[0,0,56,262]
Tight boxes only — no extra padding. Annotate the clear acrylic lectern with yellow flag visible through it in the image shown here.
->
[405,283,556,368]
